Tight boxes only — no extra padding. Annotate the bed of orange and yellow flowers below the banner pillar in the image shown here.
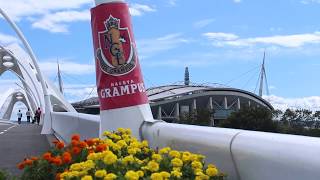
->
[18,128,225,180]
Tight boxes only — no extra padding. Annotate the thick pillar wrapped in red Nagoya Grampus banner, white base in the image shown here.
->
[91,0,153,137]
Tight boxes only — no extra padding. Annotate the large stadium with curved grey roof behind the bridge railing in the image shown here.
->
[72,68,273,125]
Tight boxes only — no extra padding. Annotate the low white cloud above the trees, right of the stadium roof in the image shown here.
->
[263,95,320,111]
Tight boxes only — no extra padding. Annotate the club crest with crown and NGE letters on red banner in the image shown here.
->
[96,15,136,76]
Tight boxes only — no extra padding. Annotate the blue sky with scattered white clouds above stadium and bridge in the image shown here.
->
[0,0,320,109]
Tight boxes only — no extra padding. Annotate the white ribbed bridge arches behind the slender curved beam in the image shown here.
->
[0,44,75,124]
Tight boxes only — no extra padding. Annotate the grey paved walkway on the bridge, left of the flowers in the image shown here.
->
[0,123,50,175]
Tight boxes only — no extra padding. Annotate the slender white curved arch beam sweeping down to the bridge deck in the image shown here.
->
[0,8,52,134]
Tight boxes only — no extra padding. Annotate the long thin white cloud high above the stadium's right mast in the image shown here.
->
[203,32,320,48]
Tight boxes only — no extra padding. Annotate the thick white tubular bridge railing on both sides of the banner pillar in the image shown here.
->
[52,112,320,180]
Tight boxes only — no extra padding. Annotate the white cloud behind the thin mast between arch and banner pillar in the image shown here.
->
[39,60,95,75]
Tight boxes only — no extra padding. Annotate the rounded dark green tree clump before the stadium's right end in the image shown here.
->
[219,108,279,132]
